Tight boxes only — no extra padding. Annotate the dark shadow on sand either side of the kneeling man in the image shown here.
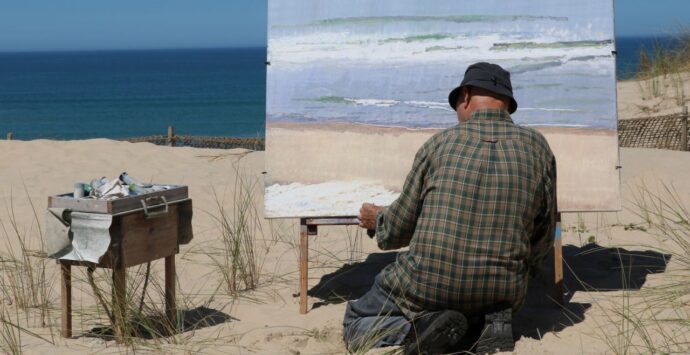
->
[309,244,671,339]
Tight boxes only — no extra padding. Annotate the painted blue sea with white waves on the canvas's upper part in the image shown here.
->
[267,2,616,129]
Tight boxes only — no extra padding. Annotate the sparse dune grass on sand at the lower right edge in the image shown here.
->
[576,183,690,355]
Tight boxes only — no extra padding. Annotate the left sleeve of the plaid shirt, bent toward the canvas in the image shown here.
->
[376,145,429,250]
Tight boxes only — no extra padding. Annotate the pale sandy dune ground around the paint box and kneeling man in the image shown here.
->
[0,140,690,354]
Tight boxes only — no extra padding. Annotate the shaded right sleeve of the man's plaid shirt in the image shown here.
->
[528,155,558,274]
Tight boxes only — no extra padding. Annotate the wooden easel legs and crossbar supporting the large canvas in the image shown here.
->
[299,212,565,314]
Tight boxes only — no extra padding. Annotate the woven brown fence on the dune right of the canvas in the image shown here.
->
[618,107,690,151]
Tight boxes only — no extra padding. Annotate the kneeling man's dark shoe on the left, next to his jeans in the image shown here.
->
[404,311,467,355]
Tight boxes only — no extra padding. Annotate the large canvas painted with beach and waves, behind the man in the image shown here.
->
[265,0,620,218]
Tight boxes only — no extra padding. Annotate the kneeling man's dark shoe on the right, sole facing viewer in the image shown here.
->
[476,308,515,355]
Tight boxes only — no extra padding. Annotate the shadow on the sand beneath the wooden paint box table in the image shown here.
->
[83,306,237,340]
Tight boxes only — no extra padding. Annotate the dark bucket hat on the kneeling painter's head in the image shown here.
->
[448,62,517,114]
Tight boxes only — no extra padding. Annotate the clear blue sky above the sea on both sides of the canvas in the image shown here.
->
[0,0,690,51]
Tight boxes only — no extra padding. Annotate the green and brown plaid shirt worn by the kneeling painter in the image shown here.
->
[376,109,556,317]
